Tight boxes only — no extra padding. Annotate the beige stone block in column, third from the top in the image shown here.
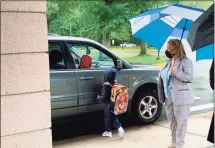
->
[1,53,50,95]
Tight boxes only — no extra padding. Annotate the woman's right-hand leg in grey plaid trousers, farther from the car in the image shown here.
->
[173,105,190,148]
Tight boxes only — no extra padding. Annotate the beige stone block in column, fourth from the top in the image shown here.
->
[1,92,51,136]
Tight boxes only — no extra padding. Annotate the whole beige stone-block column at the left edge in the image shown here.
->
[1,1,52,148]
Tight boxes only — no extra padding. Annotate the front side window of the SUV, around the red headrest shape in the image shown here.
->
[67,43,115,69]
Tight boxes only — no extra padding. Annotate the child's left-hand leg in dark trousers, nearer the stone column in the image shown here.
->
[104,103,111,132]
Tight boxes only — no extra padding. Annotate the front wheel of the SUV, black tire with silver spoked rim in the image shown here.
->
[132,90,163,125]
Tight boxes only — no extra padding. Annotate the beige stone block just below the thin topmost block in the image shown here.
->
[1,12,48,54]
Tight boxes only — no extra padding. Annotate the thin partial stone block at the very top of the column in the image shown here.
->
[1,0,46,12]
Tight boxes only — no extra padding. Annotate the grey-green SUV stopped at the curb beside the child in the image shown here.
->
[48,36,162,124]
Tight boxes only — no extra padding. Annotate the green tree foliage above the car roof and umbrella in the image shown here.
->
[47,0,213,46]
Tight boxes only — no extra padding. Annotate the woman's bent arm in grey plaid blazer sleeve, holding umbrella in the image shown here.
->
[172,59,193,83]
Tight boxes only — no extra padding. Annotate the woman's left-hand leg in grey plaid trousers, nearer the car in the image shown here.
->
[165,99,177,146]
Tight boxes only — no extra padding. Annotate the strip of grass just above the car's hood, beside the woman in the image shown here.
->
[123,55,166,66]
